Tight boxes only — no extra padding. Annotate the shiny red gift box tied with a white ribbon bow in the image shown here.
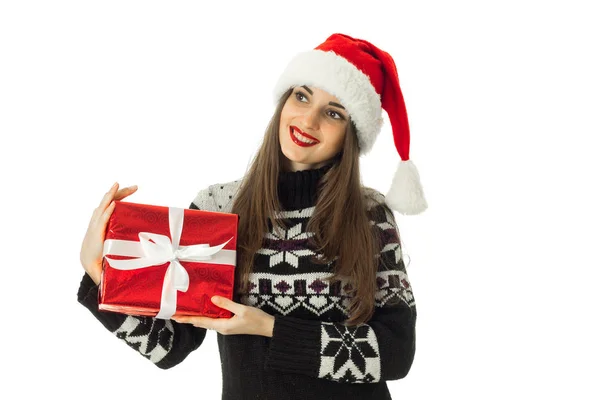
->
[98,201,238,319]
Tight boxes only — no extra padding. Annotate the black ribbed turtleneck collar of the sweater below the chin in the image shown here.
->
[278,163,333,210]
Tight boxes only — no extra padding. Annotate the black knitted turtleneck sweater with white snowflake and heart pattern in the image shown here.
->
[78,166,417,400]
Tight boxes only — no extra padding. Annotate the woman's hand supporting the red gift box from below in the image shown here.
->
[171,296,275,337]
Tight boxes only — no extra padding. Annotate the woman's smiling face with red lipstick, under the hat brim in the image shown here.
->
[279,86,349,171]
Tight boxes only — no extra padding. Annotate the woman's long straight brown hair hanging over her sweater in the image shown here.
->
[231,88,380,326]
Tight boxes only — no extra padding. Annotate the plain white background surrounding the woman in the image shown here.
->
[0,0,600,399]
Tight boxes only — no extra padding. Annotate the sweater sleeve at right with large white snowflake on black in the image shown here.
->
[265,205,417,383]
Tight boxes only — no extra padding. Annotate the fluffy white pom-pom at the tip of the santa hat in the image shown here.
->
[385,160,427,215]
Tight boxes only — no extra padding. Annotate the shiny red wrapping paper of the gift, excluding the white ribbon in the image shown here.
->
[98,201,238,318]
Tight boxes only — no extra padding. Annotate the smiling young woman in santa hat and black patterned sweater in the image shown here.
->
[78,34,427,400]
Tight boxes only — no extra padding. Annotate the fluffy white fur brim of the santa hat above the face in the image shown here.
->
[274,50,383,154]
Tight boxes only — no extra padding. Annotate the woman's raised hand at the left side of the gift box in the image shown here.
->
[79,183,137,285]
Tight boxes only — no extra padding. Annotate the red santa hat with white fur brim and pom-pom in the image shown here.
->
[274,33,427,215]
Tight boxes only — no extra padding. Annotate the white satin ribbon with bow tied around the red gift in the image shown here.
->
[102,207,236,319]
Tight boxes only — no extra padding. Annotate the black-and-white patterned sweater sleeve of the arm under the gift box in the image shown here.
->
[77,197,212,369]
